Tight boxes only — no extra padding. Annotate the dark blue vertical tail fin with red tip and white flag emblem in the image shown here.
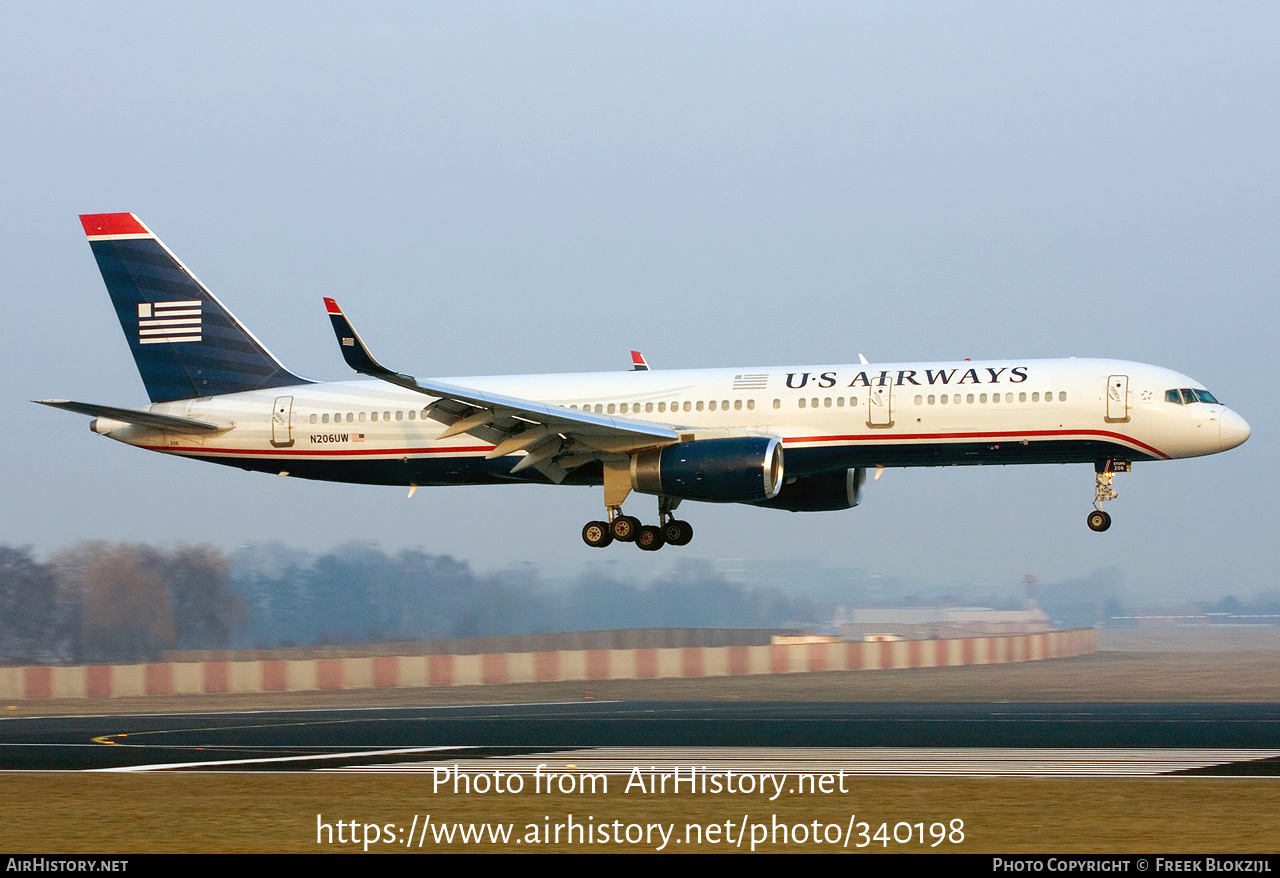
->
[81,214,311,402]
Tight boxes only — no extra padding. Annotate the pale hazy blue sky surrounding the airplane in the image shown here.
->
[0,1,1280,599]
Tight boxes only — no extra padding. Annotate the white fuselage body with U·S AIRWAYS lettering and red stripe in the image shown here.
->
[102,360,1249,484]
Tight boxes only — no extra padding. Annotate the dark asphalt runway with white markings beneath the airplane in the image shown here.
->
[0,701,1280,777]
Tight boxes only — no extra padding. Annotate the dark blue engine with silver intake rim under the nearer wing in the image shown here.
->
[631,436,782,503]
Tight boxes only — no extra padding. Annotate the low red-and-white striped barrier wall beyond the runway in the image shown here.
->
[0,628,1098,701]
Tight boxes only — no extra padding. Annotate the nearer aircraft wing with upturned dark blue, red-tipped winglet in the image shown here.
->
[325,298,680,483]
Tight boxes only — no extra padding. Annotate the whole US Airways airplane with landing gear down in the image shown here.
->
[33,214,1249,552]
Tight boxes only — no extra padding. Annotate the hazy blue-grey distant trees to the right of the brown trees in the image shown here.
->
[233,544,814,646]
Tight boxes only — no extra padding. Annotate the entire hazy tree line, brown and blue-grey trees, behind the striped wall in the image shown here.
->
[0,543,815,664]
